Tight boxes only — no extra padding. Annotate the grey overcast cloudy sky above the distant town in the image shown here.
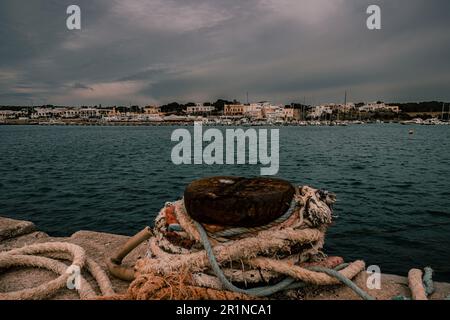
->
[0,0,450,105]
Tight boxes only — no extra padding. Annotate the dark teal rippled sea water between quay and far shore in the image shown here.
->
[0,124,450,281]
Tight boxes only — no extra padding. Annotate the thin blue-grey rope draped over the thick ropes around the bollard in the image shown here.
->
[194,221,374,300]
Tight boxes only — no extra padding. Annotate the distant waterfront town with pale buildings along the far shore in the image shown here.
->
[0,99,450,125]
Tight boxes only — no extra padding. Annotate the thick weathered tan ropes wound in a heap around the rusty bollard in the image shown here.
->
[123,186,373,299]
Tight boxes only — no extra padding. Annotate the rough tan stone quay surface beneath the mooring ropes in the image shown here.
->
[0,217,450,300]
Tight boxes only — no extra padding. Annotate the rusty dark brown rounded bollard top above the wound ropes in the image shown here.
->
[184,176,295,227]
